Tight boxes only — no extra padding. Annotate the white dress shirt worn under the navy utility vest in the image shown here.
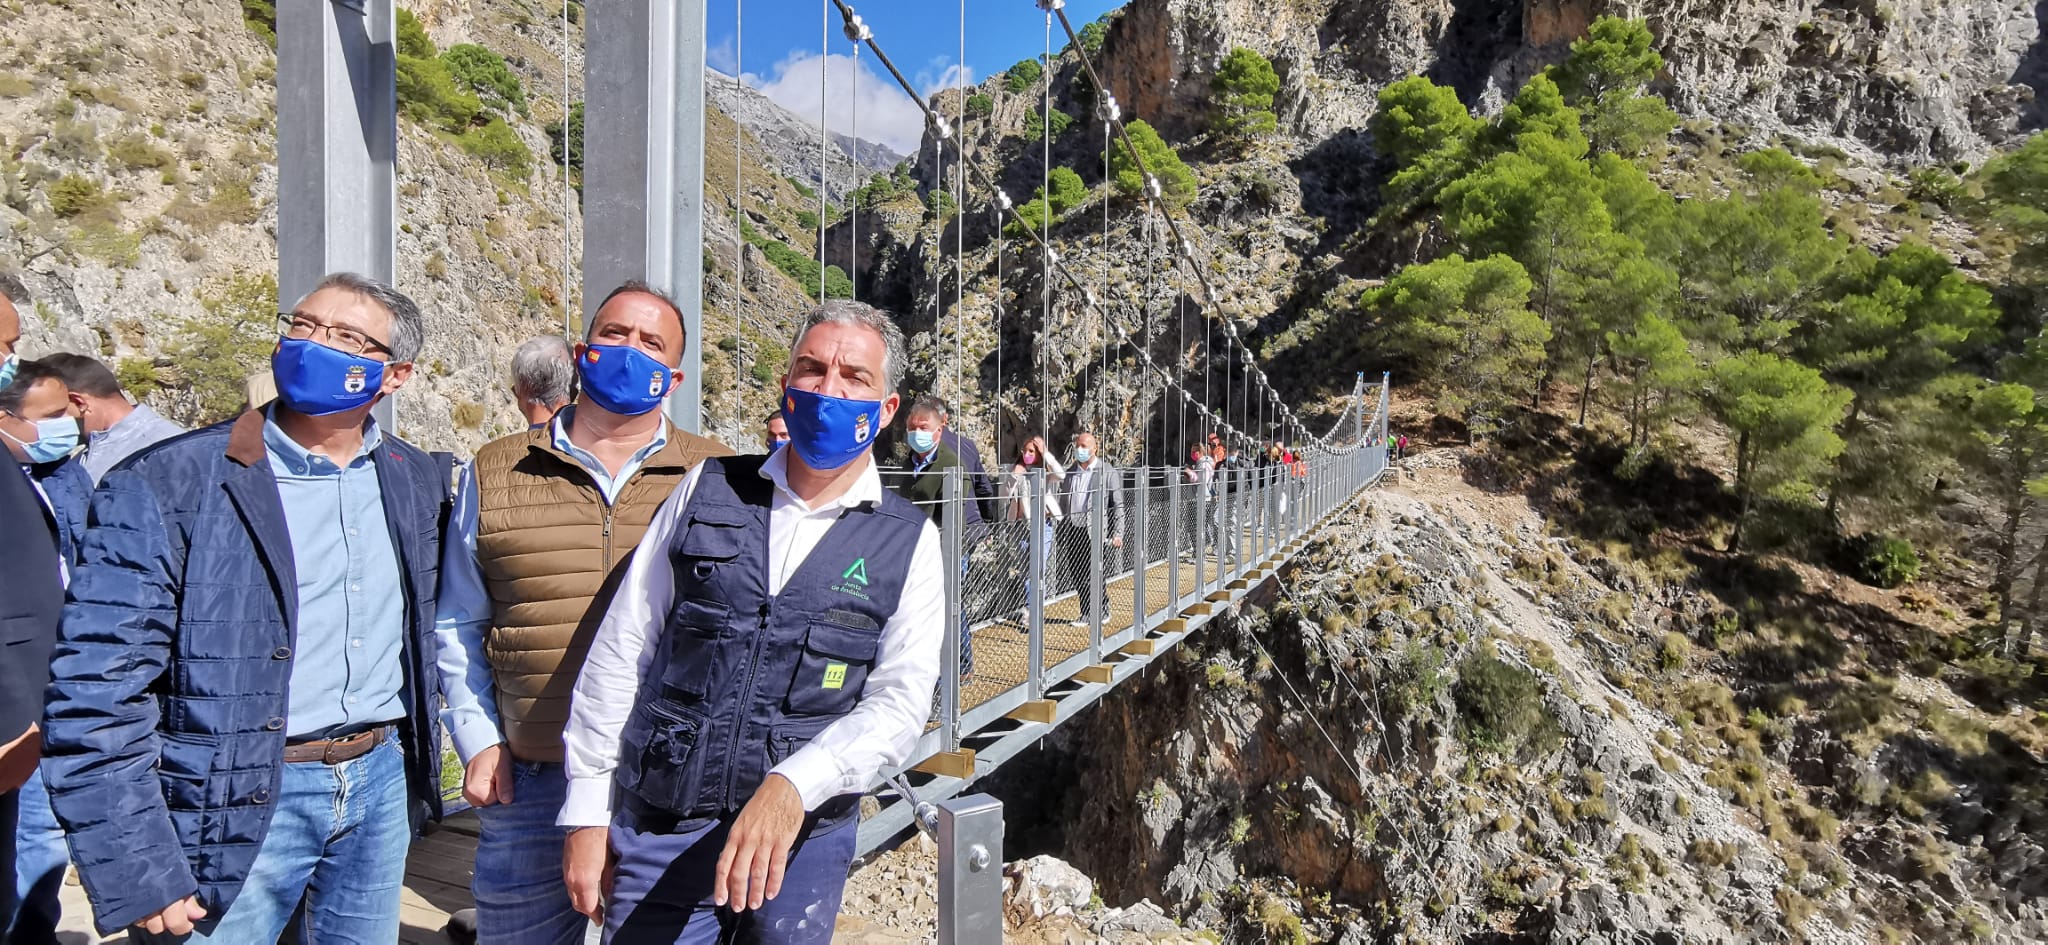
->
[557,449,946,826]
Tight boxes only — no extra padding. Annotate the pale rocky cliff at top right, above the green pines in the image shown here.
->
[1106,0,2048,164]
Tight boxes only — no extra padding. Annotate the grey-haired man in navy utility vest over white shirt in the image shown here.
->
[559,301,946,945]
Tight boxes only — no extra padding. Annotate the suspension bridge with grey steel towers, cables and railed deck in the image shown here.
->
[99,0,1386,941]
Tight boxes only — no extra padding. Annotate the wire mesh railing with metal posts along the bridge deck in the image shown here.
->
[864,375,1389,769]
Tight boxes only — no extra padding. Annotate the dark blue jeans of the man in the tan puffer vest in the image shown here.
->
[469,761,594,945]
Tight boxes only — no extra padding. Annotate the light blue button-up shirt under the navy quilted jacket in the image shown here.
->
[262,408,406,738]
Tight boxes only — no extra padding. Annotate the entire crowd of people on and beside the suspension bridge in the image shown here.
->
[0,273,1298,945]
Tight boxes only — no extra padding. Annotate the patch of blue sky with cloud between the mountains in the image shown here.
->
[707,0,1124,154]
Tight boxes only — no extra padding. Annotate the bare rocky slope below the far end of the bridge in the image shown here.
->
[983,453,2048,943]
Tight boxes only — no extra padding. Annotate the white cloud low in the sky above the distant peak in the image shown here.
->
[749,49,973,154]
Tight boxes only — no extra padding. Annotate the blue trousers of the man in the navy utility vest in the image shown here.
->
[604,814,860,945]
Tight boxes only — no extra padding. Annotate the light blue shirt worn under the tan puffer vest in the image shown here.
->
[434,406,668,765]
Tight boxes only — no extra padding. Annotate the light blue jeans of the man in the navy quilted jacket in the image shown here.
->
[129,740,412,945]
